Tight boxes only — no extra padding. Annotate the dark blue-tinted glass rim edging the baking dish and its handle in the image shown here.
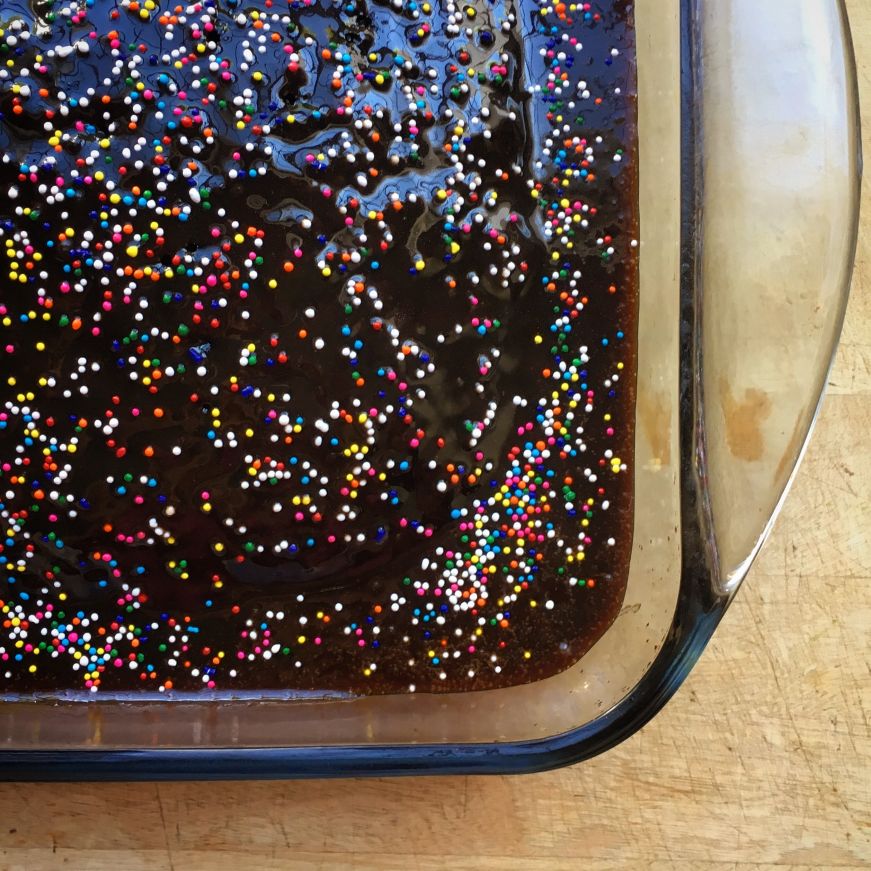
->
[0,0,862,781]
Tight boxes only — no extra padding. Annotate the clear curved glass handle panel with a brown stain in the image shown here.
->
[688,0,862,598]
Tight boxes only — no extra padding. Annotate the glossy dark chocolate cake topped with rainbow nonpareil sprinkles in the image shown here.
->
[0,0,637,693]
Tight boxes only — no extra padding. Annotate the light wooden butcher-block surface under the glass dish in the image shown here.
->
[0,0,871,871]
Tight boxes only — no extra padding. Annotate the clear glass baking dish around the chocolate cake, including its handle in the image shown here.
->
[0,0,861,780]
